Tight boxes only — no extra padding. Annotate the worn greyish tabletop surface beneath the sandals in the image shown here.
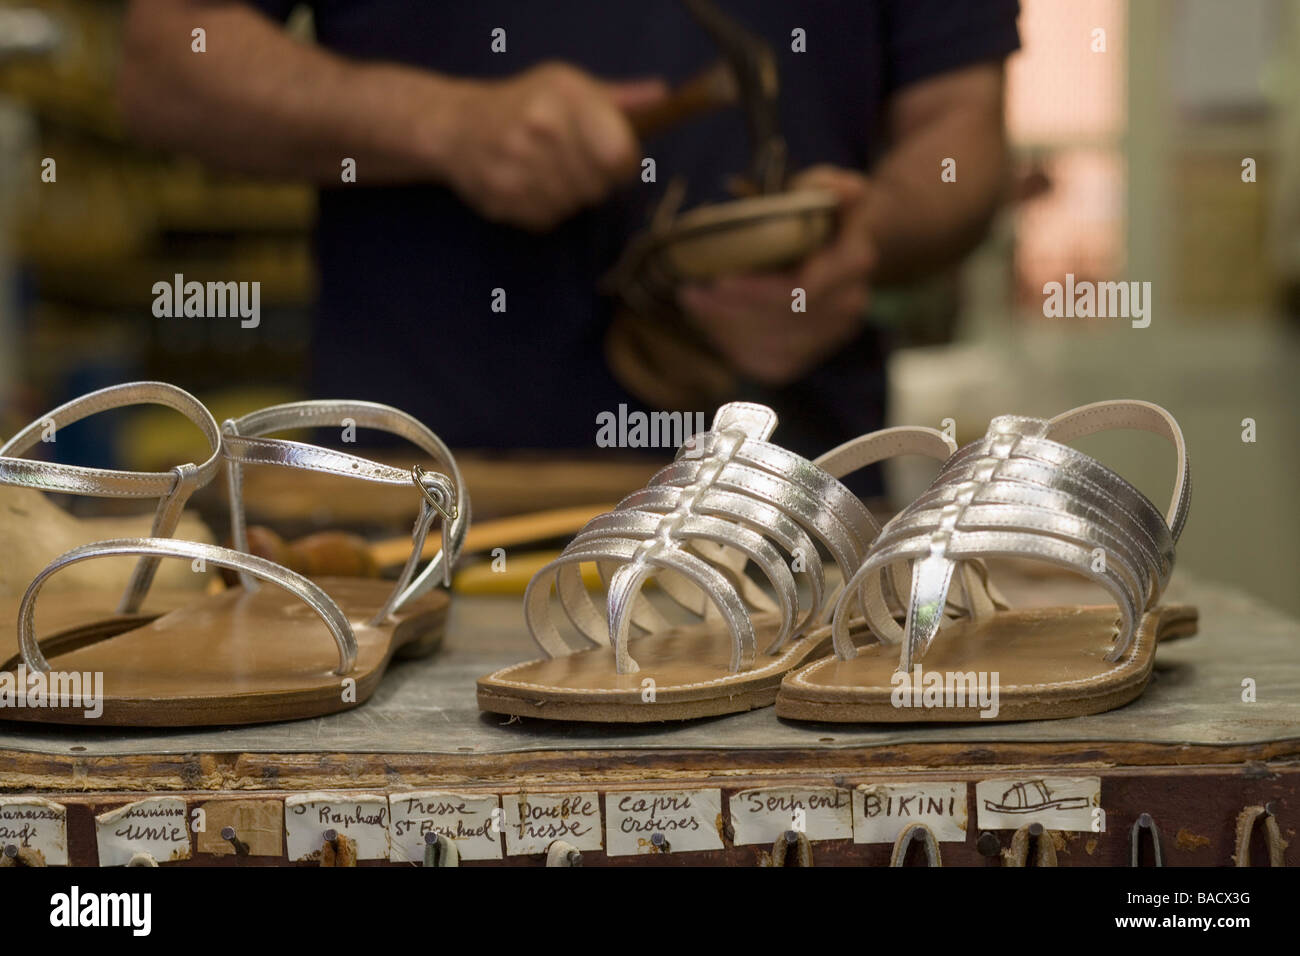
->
[0,580,1300,763]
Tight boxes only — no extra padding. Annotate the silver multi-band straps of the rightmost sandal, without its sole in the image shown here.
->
[832,401,1191,671]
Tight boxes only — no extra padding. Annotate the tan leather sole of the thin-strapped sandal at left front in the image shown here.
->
[0,578,450,727]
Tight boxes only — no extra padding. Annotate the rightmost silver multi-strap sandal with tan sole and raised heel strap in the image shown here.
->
[776,401,1196,722]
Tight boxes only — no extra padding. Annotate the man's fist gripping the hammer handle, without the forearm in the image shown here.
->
[442,64,667,232]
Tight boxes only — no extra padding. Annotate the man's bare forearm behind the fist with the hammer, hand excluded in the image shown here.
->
[120,0,463,183]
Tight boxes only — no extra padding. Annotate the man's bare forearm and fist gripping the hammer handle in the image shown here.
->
[118,0,667,208]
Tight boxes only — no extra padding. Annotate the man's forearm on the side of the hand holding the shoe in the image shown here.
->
[867,64,1006,284]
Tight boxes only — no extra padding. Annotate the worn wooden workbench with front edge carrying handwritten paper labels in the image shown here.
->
[0,579,1300,865]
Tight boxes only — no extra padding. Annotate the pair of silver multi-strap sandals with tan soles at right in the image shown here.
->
[478,401,1196,722]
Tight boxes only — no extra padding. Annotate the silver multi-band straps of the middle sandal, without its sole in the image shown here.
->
[524,402,952,674]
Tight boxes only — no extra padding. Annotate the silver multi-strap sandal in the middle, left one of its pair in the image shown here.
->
[478,402,952,722]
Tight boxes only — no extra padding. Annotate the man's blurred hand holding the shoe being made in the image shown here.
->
[679,166,876,385]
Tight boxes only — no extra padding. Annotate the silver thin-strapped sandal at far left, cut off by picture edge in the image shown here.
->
[0,381,221,669]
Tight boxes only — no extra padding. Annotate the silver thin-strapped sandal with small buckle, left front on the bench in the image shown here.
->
[0,402,469,726]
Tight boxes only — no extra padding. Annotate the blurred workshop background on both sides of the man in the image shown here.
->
[0,0,1300,611]
